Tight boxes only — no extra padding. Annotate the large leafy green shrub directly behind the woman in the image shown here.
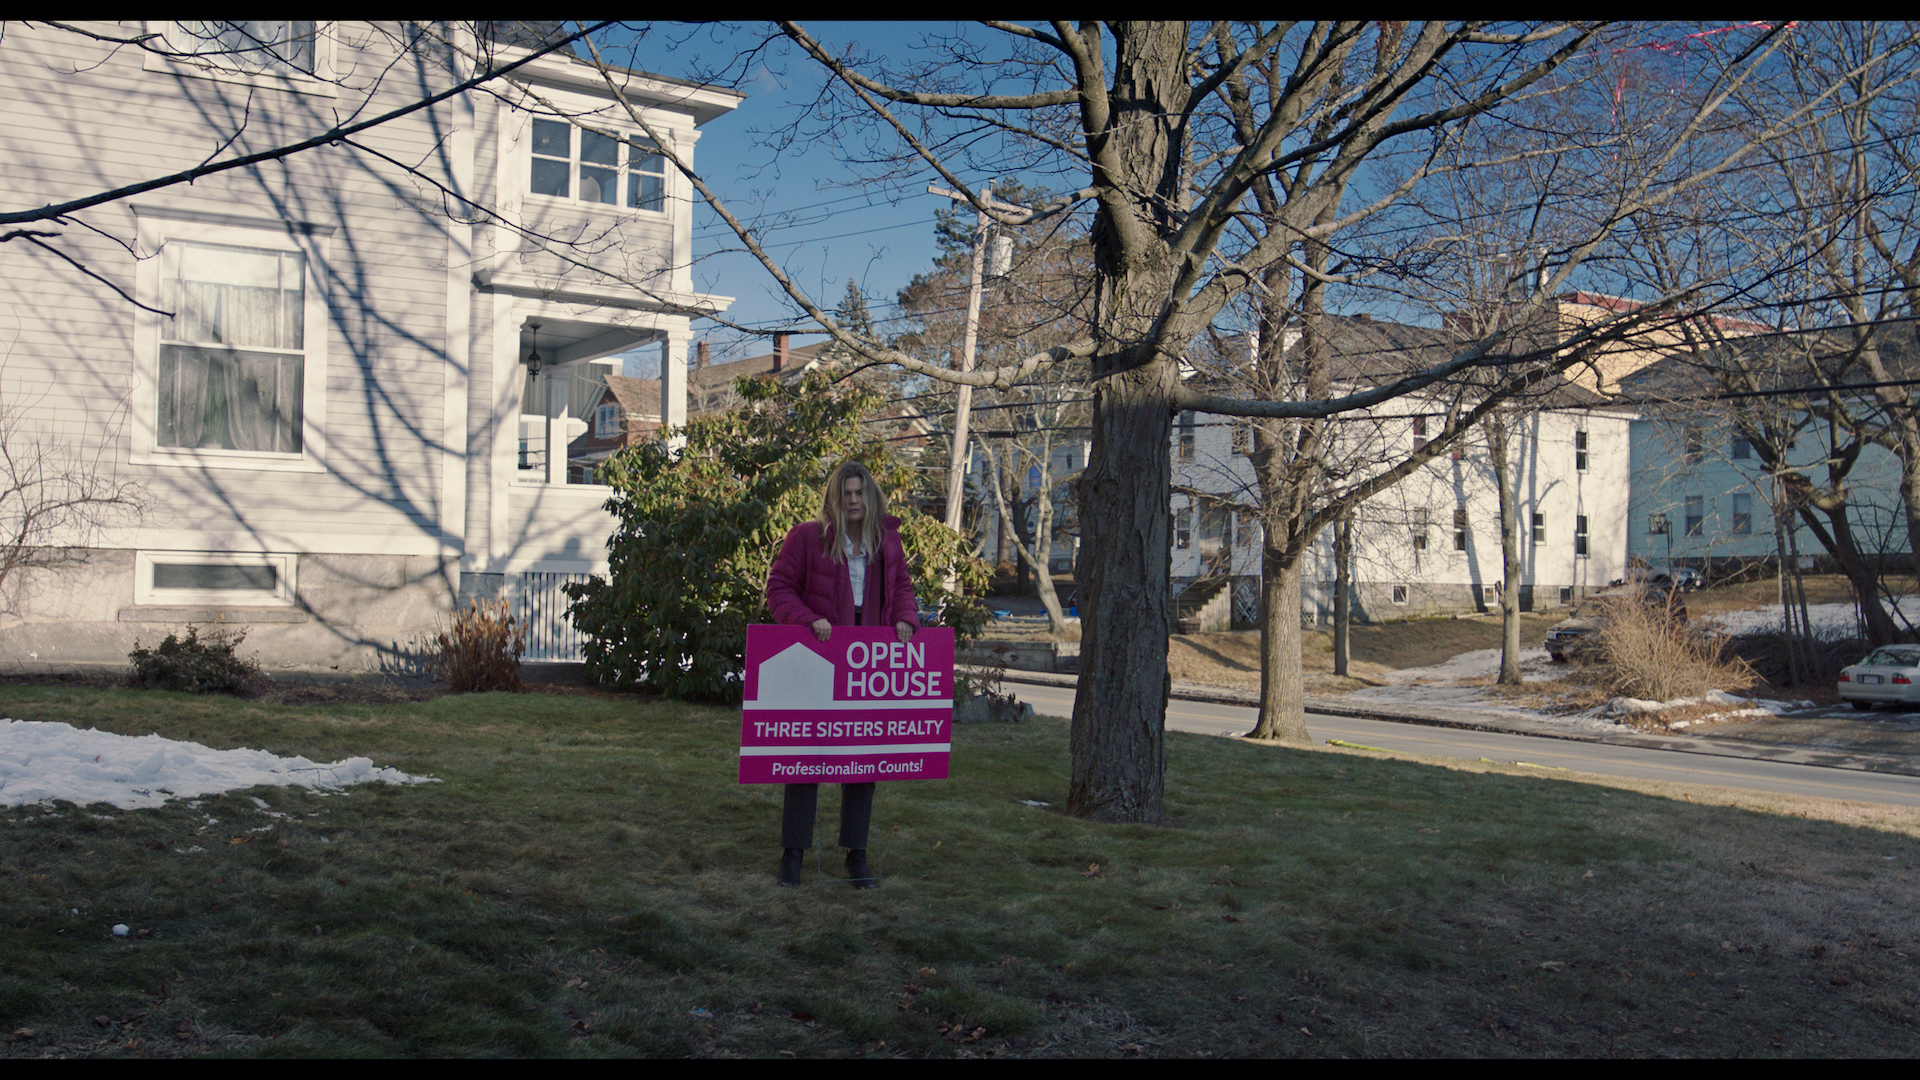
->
[566,373,989,703]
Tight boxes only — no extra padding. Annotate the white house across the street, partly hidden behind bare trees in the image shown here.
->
[1171,307,1634,628]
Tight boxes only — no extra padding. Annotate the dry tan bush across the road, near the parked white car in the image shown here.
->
[1599,590,1753,701]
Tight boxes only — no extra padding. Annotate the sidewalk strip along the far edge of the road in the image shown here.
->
[1004,669,1920,776]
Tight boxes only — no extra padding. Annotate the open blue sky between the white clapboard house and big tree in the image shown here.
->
[601,23,1021,375]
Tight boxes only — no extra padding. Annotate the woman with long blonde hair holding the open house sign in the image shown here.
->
[766,453,920,888]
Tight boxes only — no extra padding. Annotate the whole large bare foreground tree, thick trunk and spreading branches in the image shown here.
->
[568,23,1904,821]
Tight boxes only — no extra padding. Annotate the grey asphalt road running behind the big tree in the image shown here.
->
[1018,682,1920,807]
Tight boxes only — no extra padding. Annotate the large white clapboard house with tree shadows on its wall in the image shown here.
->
[0,21,741,671]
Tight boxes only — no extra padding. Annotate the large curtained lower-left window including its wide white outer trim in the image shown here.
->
[132,214,328,471]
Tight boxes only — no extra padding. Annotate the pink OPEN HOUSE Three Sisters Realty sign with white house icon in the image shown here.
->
[739,626,954,784]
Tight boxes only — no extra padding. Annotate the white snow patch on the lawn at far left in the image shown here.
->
[0,719,438,809]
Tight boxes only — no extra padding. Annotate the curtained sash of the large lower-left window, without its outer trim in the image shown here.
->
[156,240,307,454]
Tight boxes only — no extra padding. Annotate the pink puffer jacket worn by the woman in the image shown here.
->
[766,513,920,626]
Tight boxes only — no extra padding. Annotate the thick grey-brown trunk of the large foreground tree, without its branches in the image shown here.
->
[1068,23,1190,822]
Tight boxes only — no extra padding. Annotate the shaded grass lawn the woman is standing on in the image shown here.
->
[0,686,1920,1057]
